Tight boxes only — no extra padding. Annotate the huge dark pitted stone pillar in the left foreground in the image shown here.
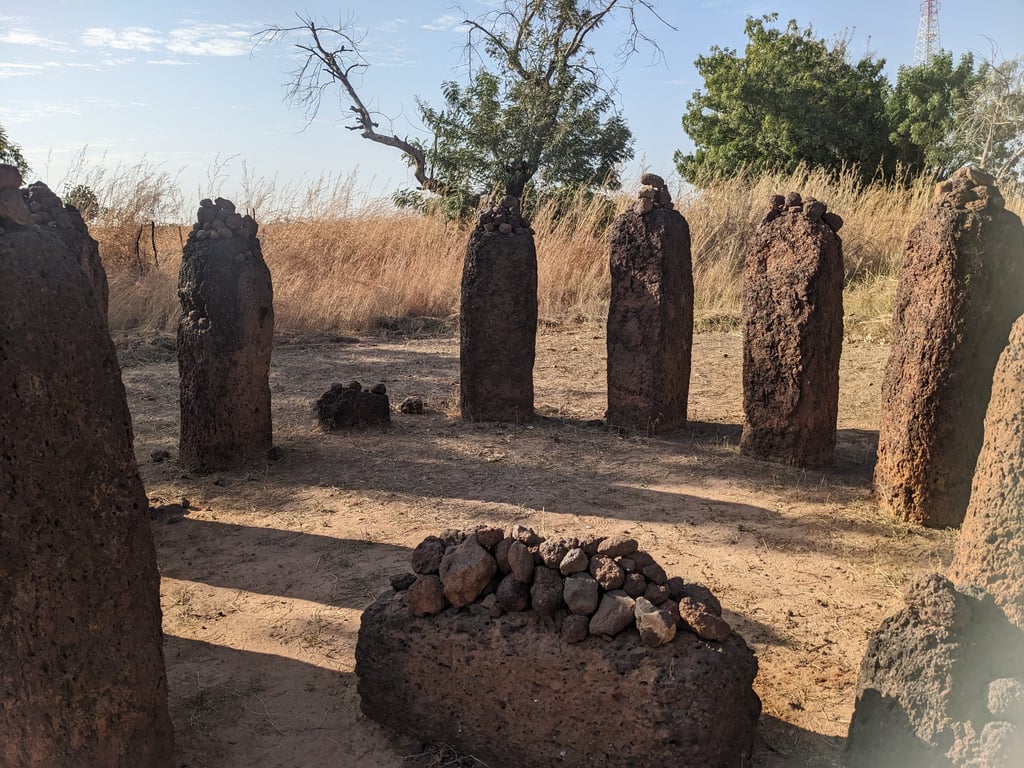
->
[0,225,174,768]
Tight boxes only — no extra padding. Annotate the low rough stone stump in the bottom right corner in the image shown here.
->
[845,574,1024,768]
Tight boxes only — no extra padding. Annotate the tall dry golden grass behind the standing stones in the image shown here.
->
[83,166,1024,339]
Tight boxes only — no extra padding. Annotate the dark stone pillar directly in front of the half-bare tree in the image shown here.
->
[459,192,537,421]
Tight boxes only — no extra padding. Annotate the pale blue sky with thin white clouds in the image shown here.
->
[0,0,1024,217]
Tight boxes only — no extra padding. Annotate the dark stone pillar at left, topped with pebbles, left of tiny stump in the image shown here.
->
[178,198,273,472]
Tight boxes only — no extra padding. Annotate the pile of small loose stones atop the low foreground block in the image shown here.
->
[391,525,732,647]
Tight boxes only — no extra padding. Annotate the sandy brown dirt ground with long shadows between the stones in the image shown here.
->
[119,325,952,768]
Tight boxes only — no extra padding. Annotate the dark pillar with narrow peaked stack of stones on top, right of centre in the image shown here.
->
[606,173,693,433]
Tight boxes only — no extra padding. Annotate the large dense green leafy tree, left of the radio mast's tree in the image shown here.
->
[676,14,889,181]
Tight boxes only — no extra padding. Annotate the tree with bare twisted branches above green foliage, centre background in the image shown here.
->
[261,0,657,210]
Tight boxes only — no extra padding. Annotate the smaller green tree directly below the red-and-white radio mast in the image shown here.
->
[886,51,979,177]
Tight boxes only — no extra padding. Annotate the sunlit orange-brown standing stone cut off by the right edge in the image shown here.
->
[949,317,1024,629]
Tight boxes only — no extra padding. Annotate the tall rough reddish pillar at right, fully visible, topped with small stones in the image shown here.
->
[874,168,1024,527]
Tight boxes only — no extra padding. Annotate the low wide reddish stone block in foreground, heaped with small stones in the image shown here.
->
[355,525,761,768]
